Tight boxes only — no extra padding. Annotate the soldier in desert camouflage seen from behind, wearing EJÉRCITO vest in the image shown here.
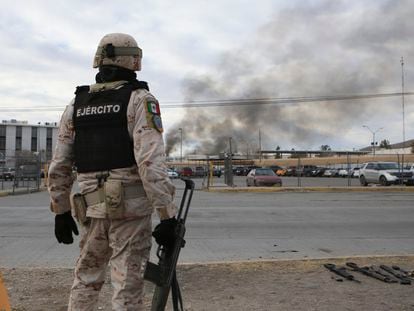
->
[48,33,176,311]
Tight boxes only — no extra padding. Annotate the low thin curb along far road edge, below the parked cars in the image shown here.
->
[207,187,414,192]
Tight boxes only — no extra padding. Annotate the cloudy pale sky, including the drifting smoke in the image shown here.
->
[0,0,414,154]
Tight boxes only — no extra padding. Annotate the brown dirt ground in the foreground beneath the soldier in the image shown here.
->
[0,256,414,311]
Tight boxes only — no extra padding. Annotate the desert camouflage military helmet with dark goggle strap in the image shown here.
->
[93,33,142,71]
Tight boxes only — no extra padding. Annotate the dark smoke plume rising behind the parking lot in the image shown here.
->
[166,1,414,154]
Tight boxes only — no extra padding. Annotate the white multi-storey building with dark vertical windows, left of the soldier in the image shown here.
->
[0,119,58,167]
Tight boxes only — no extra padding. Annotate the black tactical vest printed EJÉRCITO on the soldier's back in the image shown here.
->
[73,81,148,173]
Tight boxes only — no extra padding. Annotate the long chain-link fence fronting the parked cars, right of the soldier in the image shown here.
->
[168,154,414,187]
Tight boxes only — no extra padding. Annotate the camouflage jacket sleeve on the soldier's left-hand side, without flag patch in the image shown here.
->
[48,101,74,214]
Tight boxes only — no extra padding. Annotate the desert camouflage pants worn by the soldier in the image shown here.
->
[68,215,151,311]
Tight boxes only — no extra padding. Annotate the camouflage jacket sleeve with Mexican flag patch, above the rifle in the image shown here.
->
[131,91,177,220]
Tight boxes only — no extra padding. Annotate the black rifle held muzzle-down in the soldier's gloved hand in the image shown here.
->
[144,179,194,311]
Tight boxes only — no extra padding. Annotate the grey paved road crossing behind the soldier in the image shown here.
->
[0,181,414,267]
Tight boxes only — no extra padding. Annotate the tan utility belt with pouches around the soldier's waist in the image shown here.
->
[71,180,146,225]
